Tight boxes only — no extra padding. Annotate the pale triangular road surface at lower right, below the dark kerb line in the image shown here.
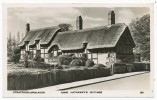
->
[68,73,150,90]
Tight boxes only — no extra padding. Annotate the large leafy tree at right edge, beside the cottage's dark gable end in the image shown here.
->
[129,14,150,61]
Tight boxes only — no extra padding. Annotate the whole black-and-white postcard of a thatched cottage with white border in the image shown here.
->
[3,4,154,97]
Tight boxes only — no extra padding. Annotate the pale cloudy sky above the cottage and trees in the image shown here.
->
[7,7,150,38]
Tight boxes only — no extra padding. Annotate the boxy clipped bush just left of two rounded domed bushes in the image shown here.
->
[58,55,72,65]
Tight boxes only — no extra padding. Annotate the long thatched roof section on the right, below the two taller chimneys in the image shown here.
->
[49,23,135,50]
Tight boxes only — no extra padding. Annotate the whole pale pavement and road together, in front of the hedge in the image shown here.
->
[33,71,150,91]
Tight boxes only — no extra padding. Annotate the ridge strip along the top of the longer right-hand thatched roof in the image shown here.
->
[59,23,126,34]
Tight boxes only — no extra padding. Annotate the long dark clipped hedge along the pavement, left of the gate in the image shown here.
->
[7,67,110,90]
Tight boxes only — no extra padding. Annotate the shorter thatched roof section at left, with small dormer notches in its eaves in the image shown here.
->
[18,26,59,46]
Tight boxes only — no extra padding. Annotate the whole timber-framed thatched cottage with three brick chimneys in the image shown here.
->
[18,11,135,65]
